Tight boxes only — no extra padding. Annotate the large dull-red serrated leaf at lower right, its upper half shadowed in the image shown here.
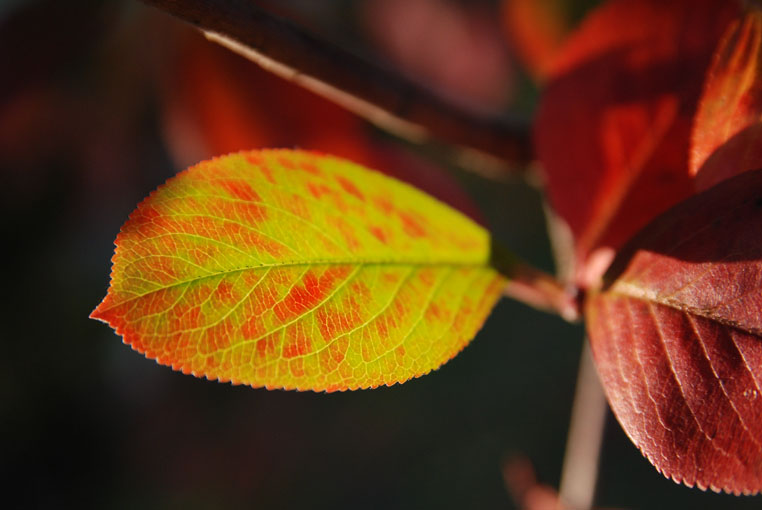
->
[586,170,762,494]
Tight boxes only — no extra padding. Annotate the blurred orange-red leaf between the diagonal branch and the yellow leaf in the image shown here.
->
[163,28,370,161]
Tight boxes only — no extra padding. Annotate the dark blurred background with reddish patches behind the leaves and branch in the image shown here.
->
[0,0,762,509]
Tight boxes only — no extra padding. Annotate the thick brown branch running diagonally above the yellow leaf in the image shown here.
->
[143,0,531,173]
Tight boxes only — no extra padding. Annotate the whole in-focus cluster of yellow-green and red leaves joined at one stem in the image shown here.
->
[92,0,762,494]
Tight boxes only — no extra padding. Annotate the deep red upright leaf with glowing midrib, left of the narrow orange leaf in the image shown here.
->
[535,0,738,287]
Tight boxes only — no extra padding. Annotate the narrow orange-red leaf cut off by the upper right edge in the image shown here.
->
[691,4,762,190]
